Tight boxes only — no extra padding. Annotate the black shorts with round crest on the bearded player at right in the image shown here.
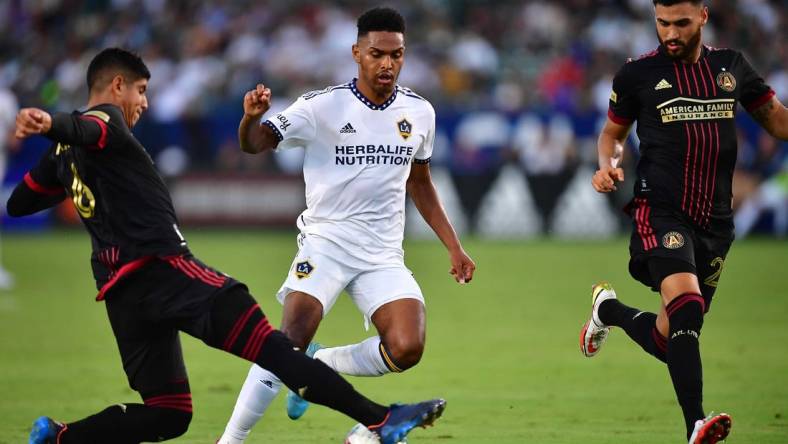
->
[629,198,733,311]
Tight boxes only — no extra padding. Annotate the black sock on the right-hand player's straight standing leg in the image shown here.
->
[665,293,705,438]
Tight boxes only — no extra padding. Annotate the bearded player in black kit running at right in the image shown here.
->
[580,0,788,444]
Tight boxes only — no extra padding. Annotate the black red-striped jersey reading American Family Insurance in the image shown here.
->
[608,46,774,227]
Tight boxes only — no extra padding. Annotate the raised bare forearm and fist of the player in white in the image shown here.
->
[238,84,279,154]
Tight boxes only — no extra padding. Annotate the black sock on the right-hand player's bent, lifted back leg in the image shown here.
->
[597,299,667,362]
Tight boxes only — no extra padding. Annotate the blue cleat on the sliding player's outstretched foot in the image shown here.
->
[368,399,446,444]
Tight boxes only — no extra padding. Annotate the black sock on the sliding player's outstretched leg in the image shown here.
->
[257,330,389,426]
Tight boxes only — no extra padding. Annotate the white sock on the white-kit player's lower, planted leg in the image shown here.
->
[217,364,282,444]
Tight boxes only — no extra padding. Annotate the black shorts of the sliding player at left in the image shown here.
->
[106,255,245,397]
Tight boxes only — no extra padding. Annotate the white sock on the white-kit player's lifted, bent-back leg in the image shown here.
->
[315,336,391,376]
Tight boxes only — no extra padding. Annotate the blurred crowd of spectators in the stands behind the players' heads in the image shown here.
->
[0,0,788,114]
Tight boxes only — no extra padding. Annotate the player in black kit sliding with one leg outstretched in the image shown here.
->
[8,48,445,444]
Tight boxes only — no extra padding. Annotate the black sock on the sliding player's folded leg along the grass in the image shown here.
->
[58,404,192,444]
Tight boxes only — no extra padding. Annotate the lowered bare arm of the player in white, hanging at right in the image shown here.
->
[407,163,476,284]
